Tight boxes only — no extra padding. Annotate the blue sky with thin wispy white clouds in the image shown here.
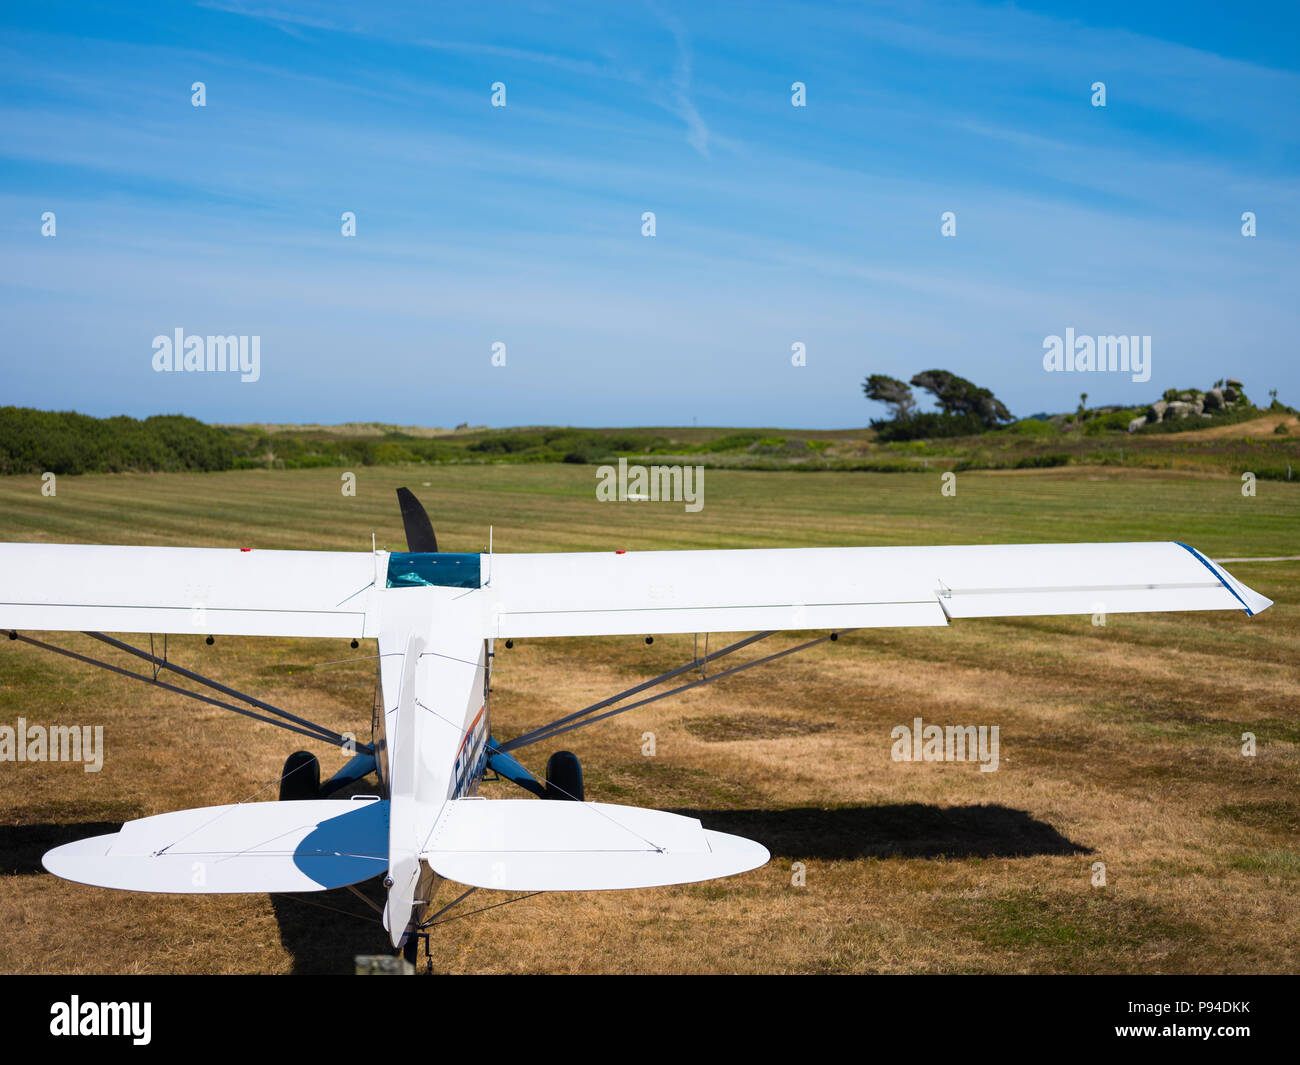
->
[0,0,1300,428]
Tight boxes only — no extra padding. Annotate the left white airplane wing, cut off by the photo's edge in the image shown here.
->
[0,544,384,638]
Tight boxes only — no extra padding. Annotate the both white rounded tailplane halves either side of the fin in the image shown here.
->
[42,798,770,895]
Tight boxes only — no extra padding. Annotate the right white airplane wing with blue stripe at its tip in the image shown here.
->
[484,542,1271,637]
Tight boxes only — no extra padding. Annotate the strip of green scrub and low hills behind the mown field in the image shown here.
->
[10,403,1300,481]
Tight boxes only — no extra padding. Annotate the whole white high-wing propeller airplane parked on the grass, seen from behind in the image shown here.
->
[0,489,1271,960]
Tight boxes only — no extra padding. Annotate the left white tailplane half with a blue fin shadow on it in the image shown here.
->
[42,798,389,895]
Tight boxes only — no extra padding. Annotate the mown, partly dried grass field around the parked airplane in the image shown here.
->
[0,464,1300,973]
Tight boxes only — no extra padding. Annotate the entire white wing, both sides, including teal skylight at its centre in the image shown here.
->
[0,542,1271,638]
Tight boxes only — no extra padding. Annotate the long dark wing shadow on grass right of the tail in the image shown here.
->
[673,802,1093,861]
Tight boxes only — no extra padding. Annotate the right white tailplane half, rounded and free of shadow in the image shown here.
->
[421,798,770,891]
